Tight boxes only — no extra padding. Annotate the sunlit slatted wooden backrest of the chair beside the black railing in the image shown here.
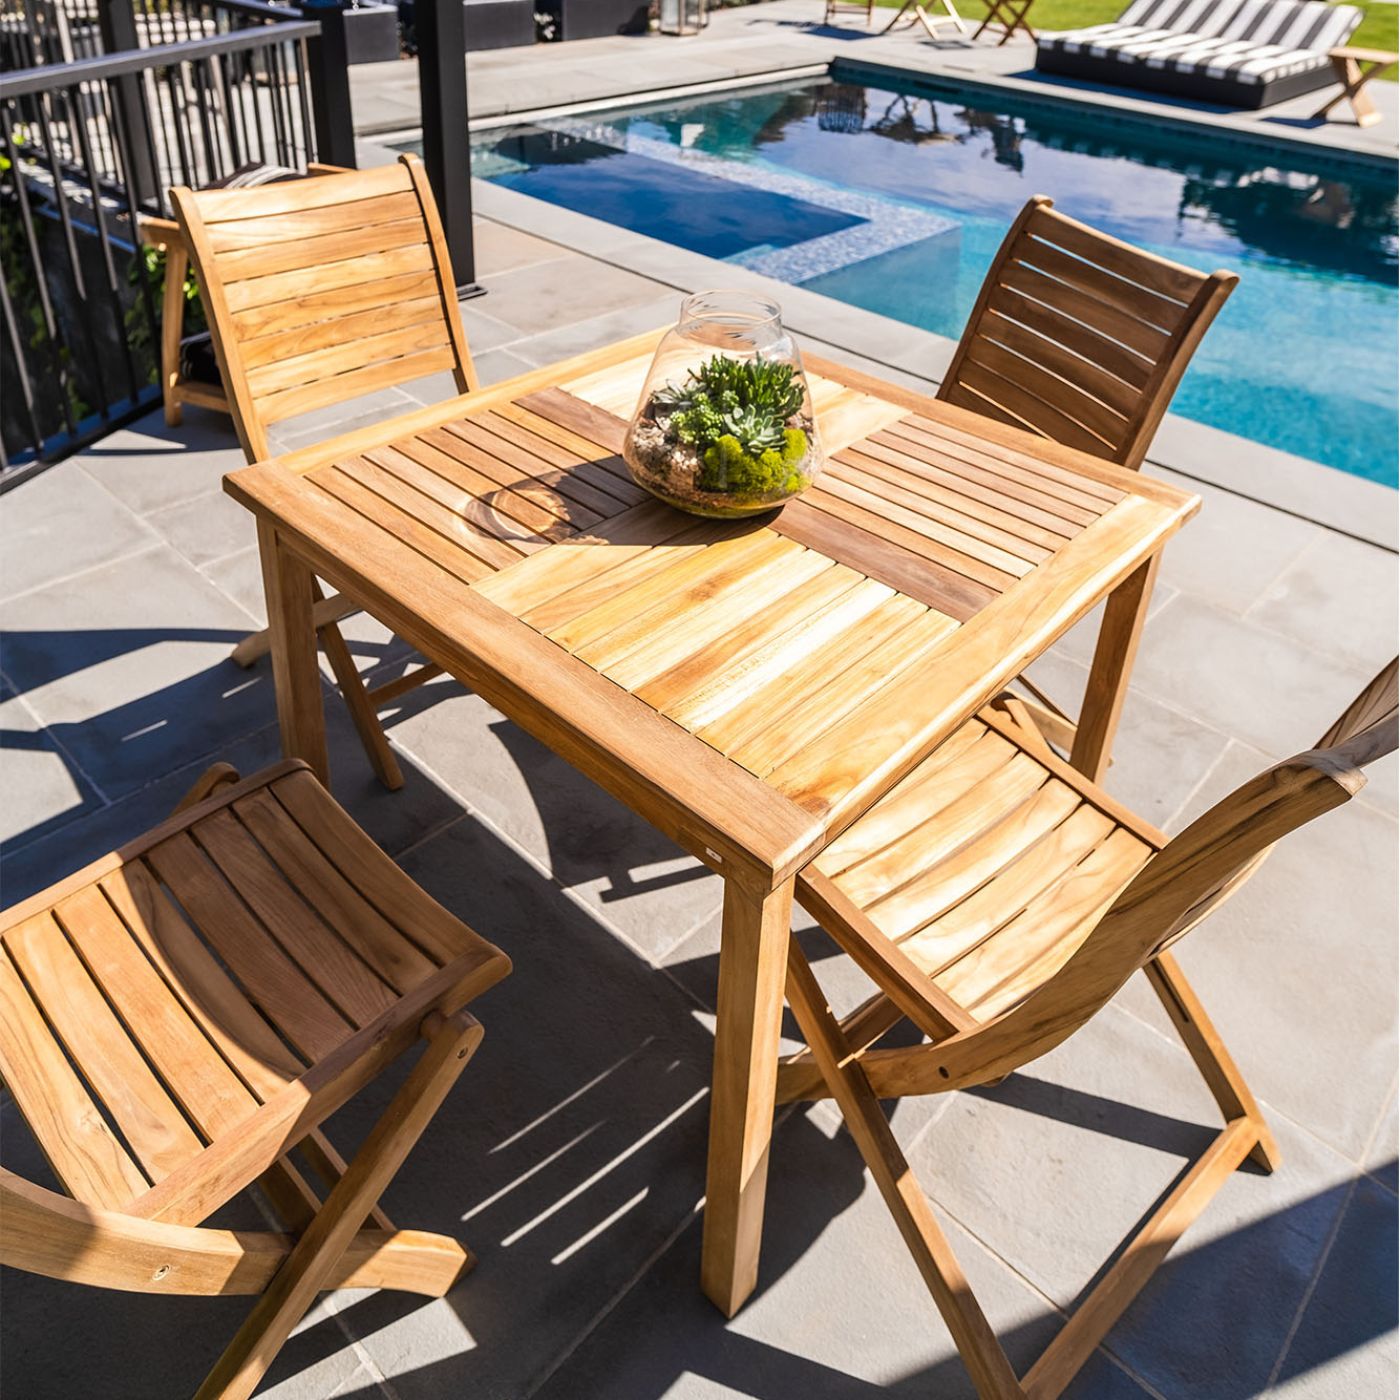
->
[171,155,476,462]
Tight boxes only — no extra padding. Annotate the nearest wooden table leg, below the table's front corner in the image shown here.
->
[700,881,792,1317]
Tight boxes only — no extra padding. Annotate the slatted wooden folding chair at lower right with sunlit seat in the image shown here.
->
[778,662,1397,1400]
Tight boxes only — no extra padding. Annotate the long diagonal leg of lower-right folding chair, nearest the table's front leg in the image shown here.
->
[787,942,1025,1400]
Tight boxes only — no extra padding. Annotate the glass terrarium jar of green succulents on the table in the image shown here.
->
[623,291,822,517]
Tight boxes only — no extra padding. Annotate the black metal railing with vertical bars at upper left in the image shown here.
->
[0,0,353,484]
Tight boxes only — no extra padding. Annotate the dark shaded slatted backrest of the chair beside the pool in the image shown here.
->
[938,195,1239,468]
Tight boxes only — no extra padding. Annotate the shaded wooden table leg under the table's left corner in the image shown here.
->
[258,521,330,784]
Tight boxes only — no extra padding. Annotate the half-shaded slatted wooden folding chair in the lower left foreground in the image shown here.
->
[0,762,511,1400]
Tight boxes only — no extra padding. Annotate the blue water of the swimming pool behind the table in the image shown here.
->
[473,73,1400,486]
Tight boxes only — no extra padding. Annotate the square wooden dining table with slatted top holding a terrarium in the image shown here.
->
[224,330,1200,1315]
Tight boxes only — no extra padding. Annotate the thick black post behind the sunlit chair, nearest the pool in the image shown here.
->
[414,0,483,297]
